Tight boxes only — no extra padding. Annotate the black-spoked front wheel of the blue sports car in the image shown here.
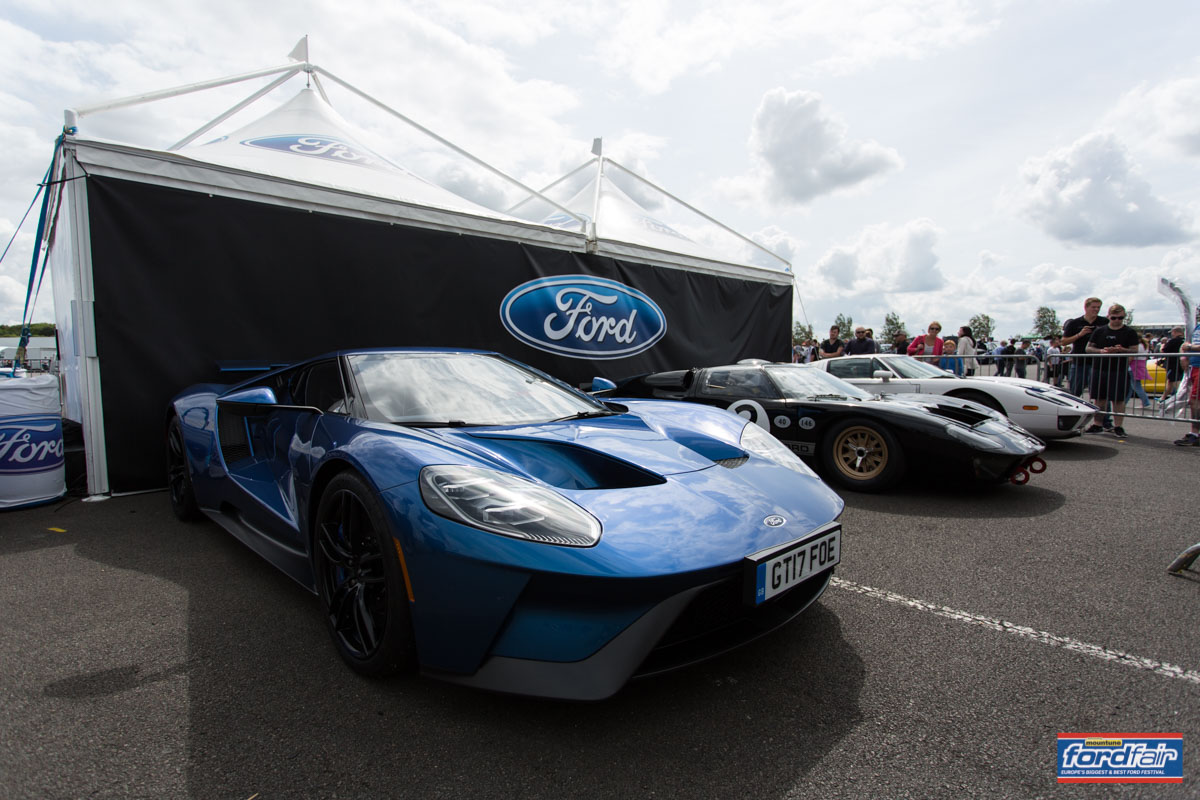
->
[313,473,415,676]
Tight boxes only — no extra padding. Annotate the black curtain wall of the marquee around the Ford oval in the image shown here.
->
[88,176,791,492]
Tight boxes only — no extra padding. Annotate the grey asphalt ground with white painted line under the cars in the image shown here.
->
[0,420,1200,800]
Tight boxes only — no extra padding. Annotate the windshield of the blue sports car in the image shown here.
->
[347,353,608,426]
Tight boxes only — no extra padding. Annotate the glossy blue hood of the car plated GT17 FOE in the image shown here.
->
[388,401,844,577]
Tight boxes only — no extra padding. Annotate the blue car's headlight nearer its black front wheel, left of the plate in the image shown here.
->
[421,464,600,547]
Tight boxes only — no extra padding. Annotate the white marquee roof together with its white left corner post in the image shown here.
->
[41,45,794,494]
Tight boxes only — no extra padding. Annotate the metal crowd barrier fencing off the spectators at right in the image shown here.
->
[922,353,1198,422]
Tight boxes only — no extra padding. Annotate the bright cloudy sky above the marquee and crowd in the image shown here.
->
[0,0,1200,336]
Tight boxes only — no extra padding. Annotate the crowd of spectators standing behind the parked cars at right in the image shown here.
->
[792,297,1200,446]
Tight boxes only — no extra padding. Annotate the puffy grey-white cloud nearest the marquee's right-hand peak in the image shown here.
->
[722,89,904,205]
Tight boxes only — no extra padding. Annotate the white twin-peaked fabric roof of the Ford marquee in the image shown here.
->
[65,43,792,284]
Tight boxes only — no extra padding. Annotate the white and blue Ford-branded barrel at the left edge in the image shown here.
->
[0,375,66,509]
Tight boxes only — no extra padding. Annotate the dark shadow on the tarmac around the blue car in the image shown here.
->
[0,495,865,800]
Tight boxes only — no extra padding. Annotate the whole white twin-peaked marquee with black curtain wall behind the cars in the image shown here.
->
[32,48,793,493]
